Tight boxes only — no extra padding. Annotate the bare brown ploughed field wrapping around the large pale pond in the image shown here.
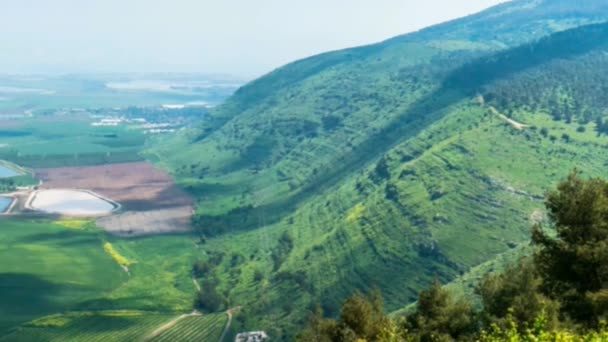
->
[36,162,194,236]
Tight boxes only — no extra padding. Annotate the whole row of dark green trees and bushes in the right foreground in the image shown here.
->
[299,171,608,342]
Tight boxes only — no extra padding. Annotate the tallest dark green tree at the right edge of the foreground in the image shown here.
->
[532,171,608,325]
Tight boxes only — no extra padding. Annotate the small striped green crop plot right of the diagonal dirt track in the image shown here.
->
[153,314,226,342]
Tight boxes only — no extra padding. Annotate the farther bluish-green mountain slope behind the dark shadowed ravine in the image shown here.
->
[153,1,608,222]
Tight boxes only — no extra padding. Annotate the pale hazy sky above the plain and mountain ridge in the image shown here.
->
[0,0,504,77]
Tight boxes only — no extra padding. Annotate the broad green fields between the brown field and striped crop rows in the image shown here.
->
[0,218,207,333]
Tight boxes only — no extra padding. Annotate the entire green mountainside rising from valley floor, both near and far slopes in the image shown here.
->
[150,0,608,336]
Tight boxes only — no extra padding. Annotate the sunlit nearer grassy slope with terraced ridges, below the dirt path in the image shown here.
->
[200,99,608,334]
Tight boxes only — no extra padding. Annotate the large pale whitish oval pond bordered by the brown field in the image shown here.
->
[28,189,119,216]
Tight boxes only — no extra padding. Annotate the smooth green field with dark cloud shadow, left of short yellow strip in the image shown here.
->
[0,218,128,331]
